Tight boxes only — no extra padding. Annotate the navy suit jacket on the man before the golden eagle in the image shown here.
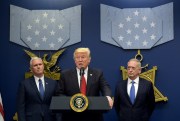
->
[17,77,58,121]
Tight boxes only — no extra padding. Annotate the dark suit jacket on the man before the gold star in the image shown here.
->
[114,78,155,121]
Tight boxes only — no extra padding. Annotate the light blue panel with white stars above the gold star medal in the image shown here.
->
[101,3,174,49]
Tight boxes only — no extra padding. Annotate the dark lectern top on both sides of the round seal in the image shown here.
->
[50,96,111,112]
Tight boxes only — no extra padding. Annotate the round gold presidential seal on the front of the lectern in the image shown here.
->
[70,93,88,112]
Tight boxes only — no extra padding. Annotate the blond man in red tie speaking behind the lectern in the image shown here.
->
[60,48,113,121]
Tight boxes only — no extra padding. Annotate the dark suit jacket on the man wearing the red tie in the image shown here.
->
[60,68,112,121]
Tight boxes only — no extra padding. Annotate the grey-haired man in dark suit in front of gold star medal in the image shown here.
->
[114,59,155,121]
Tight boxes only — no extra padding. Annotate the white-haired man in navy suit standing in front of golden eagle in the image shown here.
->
[17,57,60,121]
